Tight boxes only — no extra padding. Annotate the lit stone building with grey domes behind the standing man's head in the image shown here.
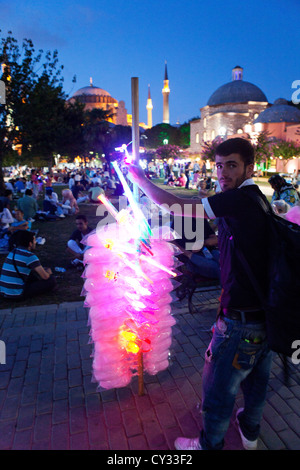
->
[189,66,300,172]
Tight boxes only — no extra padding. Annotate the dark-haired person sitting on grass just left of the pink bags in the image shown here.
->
[67,214,93,268]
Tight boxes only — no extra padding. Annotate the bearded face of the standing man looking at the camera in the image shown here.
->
[216,153,254,191]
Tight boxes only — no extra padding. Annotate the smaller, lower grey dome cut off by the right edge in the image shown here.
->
[254,98,300,124]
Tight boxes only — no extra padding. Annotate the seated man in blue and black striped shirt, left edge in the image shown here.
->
[0,230,56,300]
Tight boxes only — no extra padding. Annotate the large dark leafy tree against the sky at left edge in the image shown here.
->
[0,31,82,187]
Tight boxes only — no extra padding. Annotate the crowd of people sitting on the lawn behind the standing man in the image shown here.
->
[0,168,300,304]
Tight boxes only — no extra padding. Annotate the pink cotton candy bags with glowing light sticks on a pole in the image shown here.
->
[82,164,178,394]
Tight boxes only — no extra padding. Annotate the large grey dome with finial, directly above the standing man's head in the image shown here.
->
[207,65,268,106]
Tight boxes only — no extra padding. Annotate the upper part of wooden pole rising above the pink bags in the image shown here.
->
[131,77,140,202]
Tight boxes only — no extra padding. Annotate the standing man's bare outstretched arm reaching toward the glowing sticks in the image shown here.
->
[128,165,208,218]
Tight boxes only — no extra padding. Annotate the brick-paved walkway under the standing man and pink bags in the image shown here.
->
[0,291,300,451]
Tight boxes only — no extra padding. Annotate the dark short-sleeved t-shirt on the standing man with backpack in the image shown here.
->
[204,184,268,310]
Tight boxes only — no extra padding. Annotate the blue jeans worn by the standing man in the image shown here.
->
[200,317,272,450]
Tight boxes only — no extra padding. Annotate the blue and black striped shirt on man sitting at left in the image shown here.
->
[0,247,41,297]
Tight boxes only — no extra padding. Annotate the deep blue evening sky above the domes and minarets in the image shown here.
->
[0,0,300,125]
